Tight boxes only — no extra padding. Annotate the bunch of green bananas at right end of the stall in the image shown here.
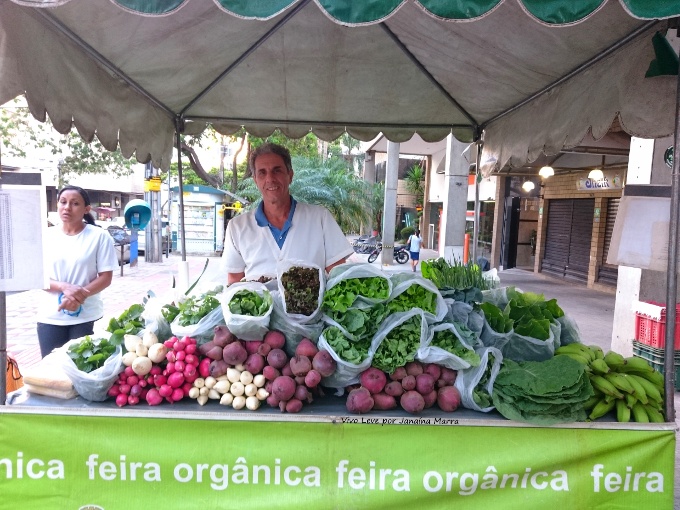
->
[555,343,665,423]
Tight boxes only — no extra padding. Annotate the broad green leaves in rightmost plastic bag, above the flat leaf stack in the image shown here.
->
[505,288,564,340]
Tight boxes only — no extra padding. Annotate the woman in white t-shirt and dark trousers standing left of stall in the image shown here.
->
[38,186,118,357]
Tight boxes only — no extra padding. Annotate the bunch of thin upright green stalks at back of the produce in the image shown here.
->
[421,257,493,303]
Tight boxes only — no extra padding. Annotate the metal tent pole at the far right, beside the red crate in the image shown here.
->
[663,64,680,422]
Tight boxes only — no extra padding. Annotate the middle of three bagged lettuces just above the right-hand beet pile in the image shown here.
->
[371,315,422,374]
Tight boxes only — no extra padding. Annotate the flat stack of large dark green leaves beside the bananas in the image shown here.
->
[493,356,593,425]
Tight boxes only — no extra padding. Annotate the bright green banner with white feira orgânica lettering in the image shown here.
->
[0,413,675,510]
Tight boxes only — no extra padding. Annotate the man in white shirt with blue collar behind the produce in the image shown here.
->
[222,143,354,285]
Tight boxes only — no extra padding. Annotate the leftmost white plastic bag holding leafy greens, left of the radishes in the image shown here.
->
[55,338,123,402]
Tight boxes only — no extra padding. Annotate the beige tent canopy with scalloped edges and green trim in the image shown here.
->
[0,0,680,173]
